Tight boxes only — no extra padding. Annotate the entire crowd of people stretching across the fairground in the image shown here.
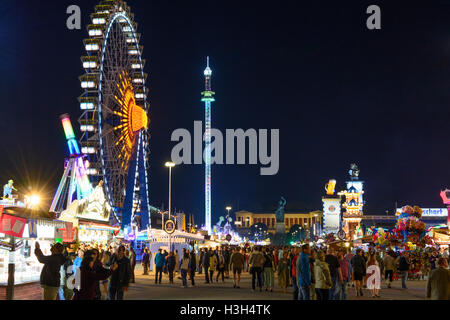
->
[35,243,450,300]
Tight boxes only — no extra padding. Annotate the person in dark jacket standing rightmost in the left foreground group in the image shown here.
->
[107,245,131,300]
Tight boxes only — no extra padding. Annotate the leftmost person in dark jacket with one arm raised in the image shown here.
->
[34,241,66,300]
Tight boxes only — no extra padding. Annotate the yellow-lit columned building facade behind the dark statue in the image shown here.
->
[234,210,322,234]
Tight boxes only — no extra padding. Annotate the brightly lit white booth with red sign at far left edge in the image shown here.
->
[0,207,68,300]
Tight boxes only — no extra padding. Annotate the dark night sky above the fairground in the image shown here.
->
[0,0,450,223]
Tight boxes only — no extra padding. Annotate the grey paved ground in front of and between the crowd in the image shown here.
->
[125,266,426,300]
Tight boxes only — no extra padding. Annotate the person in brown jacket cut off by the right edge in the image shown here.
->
[426,257,450,300]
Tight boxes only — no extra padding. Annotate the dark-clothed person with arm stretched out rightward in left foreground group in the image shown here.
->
[73,255,118,300]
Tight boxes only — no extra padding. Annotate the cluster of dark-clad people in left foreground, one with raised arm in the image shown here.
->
[35,242,136,300]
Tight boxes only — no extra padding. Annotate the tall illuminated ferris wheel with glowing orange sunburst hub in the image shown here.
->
[79,0,149,227]
